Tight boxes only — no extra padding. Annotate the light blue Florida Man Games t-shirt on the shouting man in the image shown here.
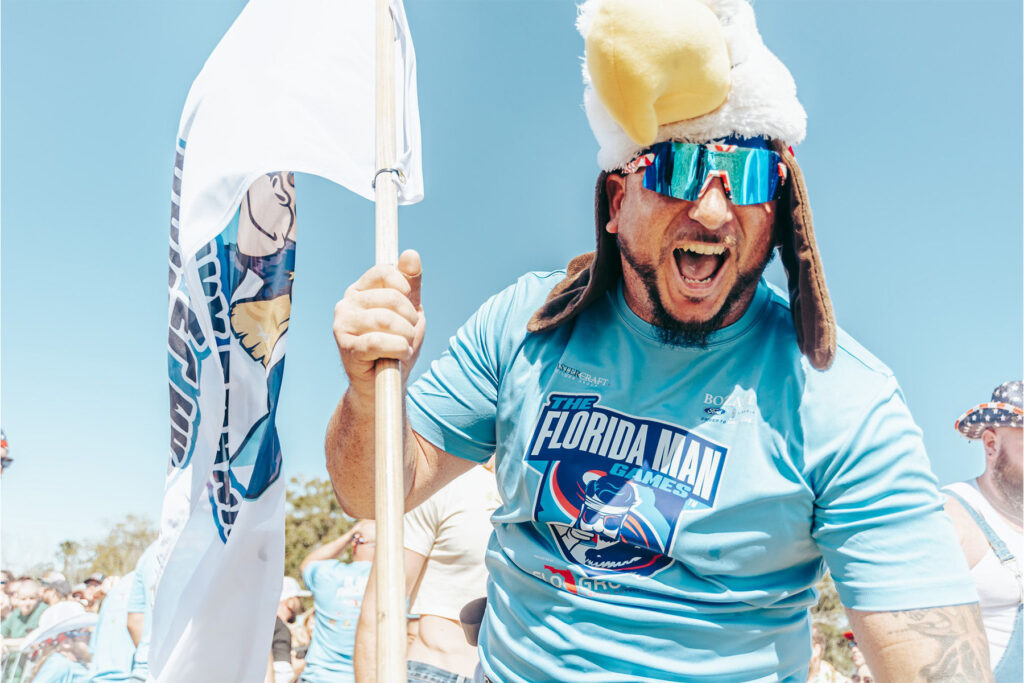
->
[409,271,977,683]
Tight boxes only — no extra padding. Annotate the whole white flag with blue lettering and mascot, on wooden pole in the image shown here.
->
[150,0,423,683]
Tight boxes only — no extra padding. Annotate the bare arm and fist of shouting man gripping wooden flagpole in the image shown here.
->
[325,251,473,518]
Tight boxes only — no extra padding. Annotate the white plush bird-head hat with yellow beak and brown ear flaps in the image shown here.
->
[529,0,836,370]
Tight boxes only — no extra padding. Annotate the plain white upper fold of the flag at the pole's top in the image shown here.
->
[178,0,423,260]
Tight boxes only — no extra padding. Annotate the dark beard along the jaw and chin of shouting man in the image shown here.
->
[618,240,775,348]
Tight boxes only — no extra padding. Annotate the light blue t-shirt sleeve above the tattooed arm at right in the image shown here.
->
[811,378,978,611]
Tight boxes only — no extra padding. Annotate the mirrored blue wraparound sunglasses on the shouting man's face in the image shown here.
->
[623,139,787,206]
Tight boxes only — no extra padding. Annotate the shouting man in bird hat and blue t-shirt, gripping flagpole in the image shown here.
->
[326,0,991,683]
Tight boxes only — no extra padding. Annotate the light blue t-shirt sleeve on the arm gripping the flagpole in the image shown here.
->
[408,278,525,463]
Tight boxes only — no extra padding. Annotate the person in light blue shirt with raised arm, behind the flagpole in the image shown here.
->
[299,520,377,683]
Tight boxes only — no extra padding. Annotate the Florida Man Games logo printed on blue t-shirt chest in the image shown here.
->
[526,394,727,577]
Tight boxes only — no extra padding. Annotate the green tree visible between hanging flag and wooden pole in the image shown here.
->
[285,477,354,578]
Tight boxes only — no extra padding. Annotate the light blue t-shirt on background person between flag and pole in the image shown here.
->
[301,560,373,683]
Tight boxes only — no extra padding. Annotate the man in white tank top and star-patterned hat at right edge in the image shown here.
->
[945,382,1024,683]
